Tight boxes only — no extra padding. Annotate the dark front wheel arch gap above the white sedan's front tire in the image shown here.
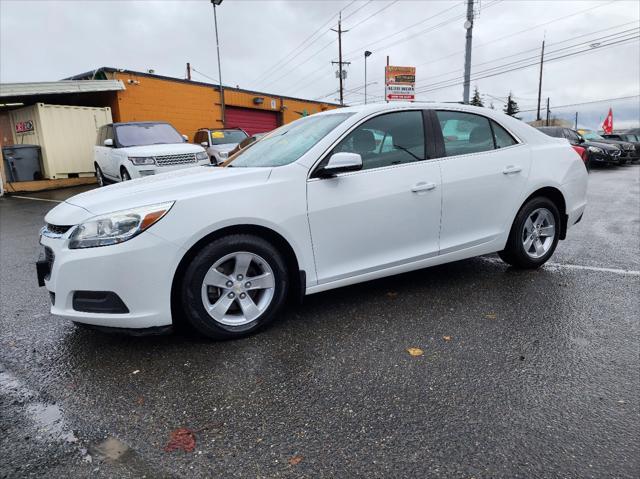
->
[171,225,306,326]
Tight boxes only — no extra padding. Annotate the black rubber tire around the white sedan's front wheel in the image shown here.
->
[180,234,289,340]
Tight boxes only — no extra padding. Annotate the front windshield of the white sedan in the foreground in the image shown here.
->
[229,113,353,167]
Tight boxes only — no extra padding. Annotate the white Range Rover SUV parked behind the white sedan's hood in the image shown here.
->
[94,121,209,186]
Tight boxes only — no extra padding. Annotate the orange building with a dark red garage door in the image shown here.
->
[68,67,338,140]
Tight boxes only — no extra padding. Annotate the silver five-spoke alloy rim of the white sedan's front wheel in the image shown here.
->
[201,251,275,326]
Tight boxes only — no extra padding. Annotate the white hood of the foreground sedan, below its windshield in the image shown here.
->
[56,166,271,218]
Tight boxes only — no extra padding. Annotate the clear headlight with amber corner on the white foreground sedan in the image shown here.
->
[69,201,174,249]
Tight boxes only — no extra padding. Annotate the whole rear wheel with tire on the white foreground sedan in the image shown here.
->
[498,197,561,269]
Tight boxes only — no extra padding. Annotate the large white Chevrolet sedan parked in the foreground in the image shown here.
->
[37,103,587,338]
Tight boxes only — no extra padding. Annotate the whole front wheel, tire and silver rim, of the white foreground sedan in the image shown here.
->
[181,234,288,339]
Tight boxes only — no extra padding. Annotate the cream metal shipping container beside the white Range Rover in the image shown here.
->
[10,103,112,179]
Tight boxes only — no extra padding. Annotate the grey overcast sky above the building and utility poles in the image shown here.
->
[0,0,640,127]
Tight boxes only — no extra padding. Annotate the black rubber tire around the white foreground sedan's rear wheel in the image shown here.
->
[498,196,562,269]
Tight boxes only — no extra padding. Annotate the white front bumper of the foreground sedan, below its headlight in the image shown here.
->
[36,230,182,329]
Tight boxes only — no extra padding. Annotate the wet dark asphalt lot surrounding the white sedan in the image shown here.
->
[0,165,640,478]
